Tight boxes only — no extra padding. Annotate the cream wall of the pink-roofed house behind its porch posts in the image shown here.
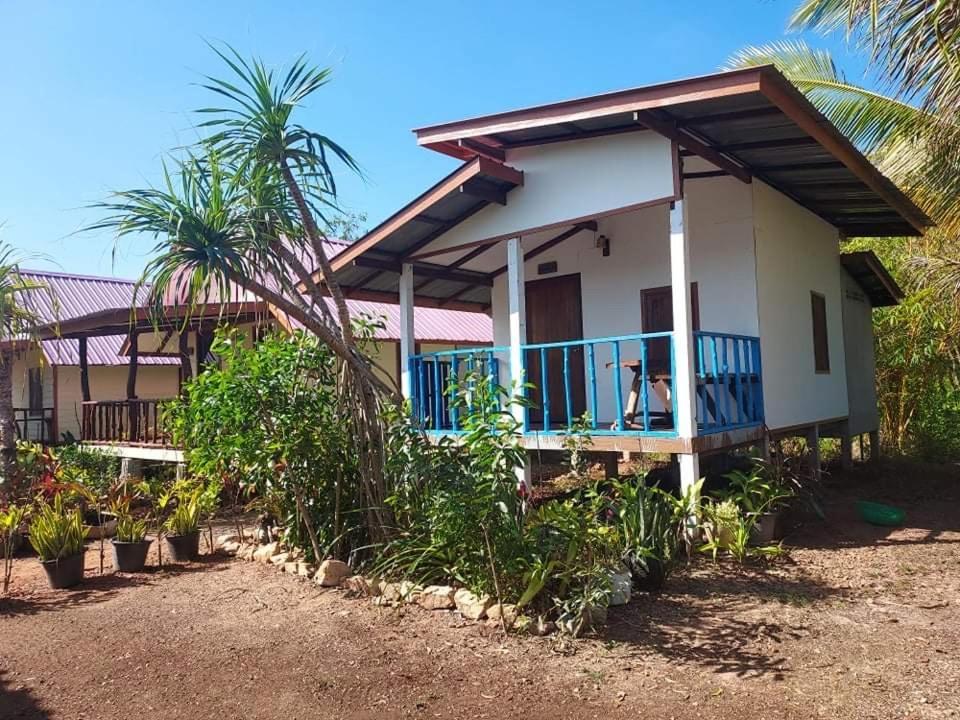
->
[57,365,179,439]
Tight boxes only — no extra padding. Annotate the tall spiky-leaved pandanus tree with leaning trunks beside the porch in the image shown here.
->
[91,47,394,541]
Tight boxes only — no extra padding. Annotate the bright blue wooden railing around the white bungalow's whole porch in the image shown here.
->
[410,332,763,437]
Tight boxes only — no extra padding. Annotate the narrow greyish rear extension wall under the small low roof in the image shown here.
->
[842,272,880,435]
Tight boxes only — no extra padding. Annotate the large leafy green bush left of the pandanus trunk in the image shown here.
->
[166,330,367,557]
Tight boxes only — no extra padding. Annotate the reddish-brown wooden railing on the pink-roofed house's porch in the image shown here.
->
[80,400,171,447]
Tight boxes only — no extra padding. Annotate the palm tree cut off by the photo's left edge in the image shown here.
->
[0,242,43,491]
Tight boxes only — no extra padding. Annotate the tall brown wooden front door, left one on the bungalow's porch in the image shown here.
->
[526,274,587,428]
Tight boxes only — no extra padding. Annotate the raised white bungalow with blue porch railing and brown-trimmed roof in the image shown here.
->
[333,67,930,485]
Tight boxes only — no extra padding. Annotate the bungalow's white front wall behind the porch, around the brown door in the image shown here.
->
[492,178,759,420]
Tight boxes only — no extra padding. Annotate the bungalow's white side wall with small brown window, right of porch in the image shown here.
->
[752,180,847,430]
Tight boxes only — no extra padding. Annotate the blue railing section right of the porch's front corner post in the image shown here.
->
[693,331,763,434]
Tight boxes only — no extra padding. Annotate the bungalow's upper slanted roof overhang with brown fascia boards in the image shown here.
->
[414,65,931,237]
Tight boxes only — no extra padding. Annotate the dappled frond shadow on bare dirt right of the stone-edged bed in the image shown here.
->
[605,560,836,679]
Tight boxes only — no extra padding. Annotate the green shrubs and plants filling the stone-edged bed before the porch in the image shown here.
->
[158,332,788,632]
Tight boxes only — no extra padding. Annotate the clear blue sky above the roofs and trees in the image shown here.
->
[0,0,860,277]
